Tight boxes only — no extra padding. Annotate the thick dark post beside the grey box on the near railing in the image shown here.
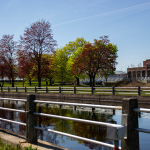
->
[121,98,139,150]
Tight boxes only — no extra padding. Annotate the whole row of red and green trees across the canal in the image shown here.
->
[0,22,118,87]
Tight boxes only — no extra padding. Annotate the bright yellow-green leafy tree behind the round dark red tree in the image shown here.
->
[55,37,88,85]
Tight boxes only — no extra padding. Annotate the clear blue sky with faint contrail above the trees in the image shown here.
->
[0,0,150,71]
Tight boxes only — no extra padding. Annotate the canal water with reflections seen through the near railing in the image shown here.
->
[0,102,150,150]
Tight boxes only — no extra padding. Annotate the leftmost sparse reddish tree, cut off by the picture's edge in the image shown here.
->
[0,35,17,87]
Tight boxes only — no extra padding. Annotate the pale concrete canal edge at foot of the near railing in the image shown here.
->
[0,128,70,150]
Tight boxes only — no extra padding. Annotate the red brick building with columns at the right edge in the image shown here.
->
[127,59,150,79]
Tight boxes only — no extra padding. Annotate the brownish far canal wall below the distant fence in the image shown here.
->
[0,92,150,106]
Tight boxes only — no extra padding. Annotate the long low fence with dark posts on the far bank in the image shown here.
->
[1,86,150,96]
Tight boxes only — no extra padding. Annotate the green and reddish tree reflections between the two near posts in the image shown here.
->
[37,106,116,149]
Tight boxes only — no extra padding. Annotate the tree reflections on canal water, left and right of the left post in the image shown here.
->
[0,102,117,150]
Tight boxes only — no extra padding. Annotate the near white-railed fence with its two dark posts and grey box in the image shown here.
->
[0,95,150,149]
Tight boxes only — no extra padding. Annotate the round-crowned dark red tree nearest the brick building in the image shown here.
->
[72,36,117,86]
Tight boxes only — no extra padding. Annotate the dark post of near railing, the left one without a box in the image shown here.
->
[26,94,37,143]
